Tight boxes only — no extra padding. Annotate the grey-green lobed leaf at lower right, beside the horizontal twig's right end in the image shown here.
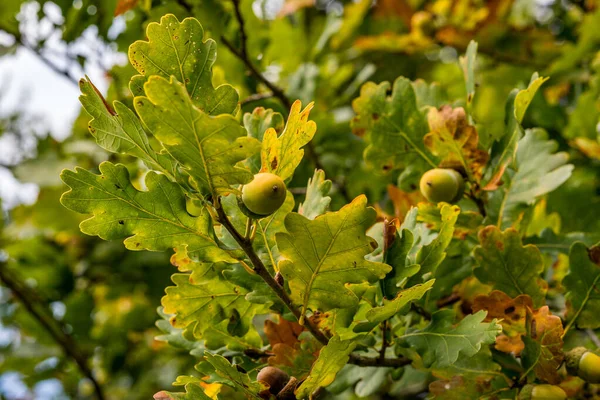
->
[400,310,502,368]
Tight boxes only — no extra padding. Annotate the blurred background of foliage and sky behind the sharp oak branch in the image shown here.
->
[0,0,600,399]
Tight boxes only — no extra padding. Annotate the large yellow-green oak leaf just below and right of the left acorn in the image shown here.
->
[276,195,390,316]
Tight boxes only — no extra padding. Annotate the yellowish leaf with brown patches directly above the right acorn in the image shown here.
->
[423,105,488,181]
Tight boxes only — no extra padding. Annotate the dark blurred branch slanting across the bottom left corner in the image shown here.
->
[0,263,105,400]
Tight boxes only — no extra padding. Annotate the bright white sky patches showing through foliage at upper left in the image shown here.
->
[0,0,127,210]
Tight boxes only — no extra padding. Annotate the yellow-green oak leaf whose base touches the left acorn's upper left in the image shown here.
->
[134,76,260,196]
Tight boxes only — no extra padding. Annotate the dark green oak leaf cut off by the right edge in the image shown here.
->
[562,242,600,329]
